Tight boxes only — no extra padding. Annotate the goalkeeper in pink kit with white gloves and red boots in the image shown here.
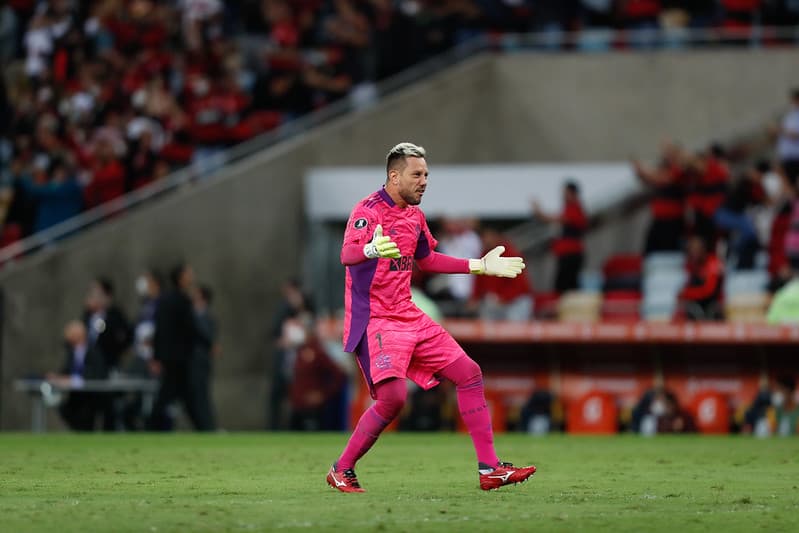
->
[327,143,535,492]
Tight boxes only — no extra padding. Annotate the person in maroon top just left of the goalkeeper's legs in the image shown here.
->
[284,313,347,431]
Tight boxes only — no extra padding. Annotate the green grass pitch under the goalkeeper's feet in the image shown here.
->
[0,433,799,533]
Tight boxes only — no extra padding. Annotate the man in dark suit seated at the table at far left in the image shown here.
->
[46,320,109,431]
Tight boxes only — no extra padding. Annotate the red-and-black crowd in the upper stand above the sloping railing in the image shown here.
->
[0,0,799,247]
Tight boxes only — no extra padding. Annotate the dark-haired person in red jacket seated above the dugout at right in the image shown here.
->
[678,235,724,320]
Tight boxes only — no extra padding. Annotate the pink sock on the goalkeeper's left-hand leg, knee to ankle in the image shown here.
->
[336,378,408,471]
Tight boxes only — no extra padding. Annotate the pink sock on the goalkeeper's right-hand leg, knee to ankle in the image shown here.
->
[439,357,499,468]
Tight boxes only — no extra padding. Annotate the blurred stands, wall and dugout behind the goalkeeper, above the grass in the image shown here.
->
[0,0,799,436]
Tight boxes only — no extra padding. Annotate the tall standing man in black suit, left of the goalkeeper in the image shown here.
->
[149,264,211,431]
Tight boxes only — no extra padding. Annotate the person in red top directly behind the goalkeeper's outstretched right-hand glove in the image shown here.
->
[470,228,533,321]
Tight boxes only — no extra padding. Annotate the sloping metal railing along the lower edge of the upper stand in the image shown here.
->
[0,26,799,267]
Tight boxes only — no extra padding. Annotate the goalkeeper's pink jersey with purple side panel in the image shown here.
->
[344,189,438,352]
